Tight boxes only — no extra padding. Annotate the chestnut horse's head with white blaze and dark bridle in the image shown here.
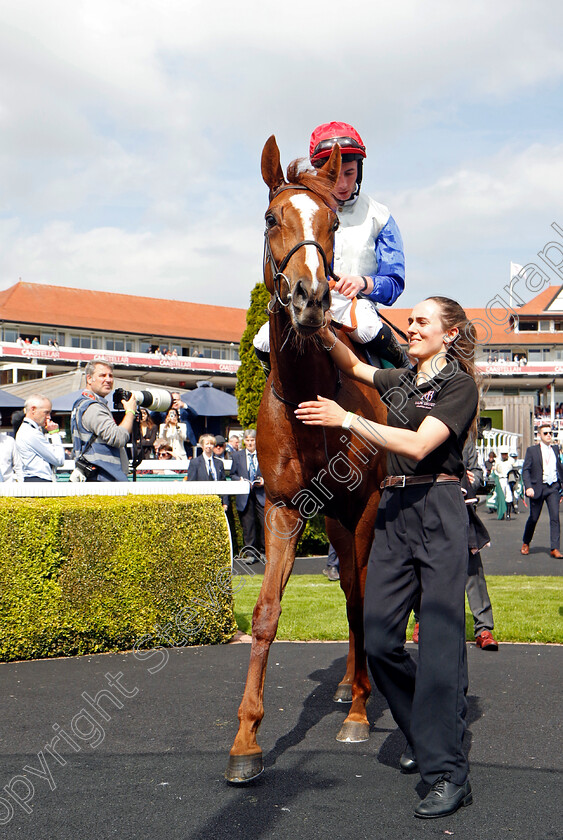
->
[262,136,341,337]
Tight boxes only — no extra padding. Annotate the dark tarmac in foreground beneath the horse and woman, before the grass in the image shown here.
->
[0,640,563,840]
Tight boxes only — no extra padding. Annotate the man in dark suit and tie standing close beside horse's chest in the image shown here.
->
[231,429,266,565]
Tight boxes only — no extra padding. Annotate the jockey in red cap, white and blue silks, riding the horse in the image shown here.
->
[254,122,409,367]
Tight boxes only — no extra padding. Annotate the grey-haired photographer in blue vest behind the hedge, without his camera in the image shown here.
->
[70,359,137,481]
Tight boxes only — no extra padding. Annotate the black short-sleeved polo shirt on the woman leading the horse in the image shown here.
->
[373,363,479,478]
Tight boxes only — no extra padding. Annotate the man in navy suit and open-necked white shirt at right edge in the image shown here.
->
[520,423,563,560]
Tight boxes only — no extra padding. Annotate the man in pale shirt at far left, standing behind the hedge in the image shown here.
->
[16,394,65,482]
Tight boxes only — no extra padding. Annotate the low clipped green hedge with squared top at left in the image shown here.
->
[0,496,236,661]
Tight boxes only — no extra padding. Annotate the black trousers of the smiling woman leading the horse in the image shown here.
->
[364,484,468,784]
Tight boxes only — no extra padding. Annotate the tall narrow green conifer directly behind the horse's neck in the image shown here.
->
[235,283,270,429]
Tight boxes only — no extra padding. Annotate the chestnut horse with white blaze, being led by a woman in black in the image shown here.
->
[225,137,386,783]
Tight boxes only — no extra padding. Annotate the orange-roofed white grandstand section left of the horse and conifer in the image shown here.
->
[0,281,246,391]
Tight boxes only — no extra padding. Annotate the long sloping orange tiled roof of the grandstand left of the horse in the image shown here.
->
[0,281,246,343]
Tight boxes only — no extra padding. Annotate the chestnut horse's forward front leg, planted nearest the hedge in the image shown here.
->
[225,503,304,784]
